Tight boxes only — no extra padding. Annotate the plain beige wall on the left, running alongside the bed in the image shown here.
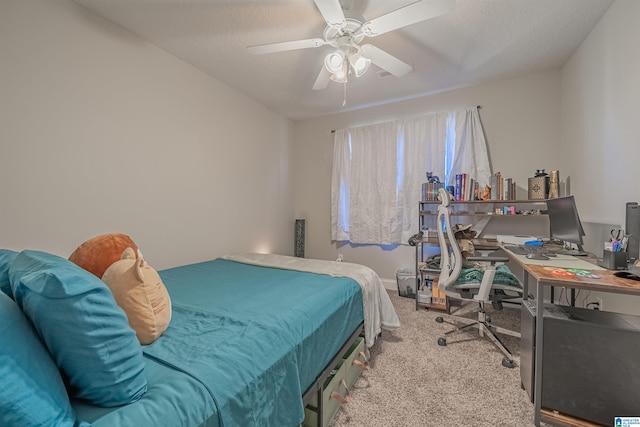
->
[0,0,294,269]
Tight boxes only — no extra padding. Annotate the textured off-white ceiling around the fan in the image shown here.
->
[74,0,613,120]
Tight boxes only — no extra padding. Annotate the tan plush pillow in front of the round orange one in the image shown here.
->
[102,248,171,345]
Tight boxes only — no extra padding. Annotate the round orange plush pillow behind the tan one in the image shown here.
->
[69,233,138,278]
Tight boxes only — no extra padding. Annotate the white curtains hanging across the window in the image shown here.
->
[331,107,491,245]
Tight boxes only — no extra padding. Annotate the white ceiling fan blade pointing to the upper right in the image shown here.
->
[360,0,456,37]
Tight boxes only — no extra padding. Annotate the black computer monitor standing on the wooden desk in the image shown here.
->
[547,196,586,255]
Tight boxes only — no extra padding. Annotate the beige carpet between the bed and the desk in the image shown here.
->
[332,291,534,427]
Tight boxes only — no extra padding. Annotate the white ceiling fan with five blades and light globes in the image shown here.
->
[247,0,455,90]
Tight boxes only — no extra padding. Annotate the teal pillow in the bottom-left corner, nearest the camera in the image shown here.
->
[0,292,87,427]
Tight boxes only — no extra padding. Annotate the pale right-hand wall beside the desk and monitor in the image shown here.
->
[562,0,640,314]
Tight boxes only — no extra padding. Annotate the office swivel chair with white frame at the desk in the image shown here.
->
[436,189,522,368]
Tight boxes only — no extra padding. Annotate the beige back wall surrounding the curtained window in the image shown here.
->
[294,70,563,283]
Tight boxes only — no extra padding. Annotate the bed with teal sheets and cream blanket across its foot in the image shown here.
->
[2,254,399,427]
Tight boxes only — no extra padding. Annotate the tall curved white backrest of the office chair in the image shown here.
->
[436,188,463,291]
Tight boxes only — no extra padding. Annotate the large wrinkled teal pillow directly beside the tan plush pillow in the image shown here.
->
[9,250,147,407]
